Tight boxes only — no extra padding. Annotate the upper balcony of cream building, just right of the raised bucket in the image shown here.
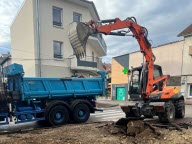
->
[88,34,107,57]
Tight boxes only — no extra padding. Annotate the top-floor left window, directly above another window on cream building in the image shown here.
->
[53,7,63,26]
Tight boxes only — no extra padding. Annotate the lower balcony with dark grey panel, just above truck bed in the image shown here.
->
[71,56,105,75]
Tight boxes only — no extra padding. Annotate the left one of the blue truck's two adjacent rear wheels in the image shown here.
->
[49,105,69,125]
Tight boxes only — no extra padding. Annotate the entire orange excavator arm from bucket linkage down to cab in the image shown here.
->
[72,17,167,99]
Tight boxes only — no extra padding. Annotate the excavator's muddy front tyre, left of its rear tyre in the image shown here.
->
[159,102,175,123]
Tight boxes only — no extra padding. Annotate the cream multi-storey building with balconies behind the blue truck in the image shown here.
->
[11,0,106,77]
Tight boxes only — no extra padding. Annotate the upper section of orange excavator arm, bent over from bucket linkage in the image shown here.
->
[87,18,154,62]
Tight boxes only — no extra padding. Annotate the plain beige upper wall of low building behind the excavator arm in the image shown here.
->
[129,40,184,76]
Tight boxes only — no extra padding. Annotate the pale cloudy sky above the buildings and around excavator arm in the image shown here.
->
[0,0,192,62]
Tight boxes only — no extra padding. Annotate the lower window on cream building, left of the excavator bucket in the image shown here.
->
[53,41,63,59]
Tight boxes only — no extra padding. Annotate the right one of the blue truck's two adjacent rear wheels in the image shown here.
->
[73,103,90,123]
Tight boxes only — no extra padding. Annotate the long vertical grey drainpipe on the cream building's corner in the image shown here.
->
[35,0,42,77]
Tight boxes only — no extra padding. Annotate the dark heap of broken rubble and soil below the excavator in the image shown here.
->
[98,118,192,136]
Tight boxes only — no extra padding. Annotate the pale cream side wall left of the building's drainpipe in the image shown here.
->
[11,0,36,76]
